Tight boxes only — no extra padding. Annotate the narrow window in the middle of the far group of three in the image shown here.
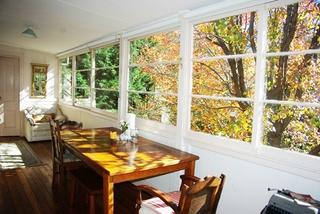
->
[75,52,92,108]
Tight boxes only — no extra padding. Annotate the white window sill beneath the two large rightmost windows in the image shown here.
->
[184,131,320,181]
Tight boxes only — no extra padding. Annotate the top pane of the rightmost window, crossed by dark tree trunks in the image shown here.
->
[268,0,320,52]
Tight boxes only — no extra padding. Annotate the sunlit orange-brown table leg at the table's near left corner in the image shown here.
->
[103,174,114,214]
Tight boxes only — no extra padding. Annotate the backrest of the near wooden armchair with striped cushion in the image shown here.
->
[179,174,225,214]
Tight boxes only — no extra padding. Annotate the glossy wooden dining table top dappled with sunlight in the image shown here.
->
[61,127,199,181]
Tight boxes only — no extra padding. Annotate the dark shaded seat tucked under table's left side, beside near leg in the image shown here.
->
[70,167,102,194]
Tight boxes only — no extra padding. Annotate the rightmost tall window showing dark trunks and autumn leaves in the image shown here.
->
[263,0,320,155]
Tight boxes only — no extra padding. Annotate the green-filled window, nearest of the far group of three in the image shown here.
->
[93,44,119,112]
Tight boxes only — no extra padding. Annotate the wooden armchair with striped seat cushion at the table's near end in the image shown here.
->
[136,174,225,214]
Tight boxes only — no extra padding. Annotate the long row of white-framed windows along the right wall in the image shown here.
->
[60,0,320,161]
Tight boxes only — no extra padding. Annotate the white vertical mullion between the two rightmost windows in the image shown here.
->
[252,7,268,147]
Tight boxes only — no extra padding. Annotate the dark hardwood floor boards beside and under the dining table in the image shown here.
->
[0,137,135,214]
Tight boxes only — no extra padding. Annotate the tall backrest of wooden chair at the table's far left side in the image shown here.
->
[50,119,63,163]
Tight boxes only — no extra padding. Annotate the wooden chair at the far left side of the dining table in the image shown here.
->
[50,119,82,188]
